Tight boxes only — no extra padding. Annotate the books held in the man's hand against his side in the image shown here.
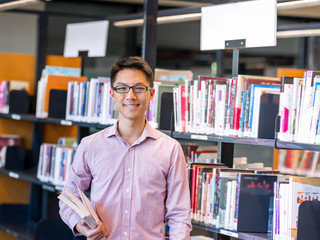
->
[58,186,105,229]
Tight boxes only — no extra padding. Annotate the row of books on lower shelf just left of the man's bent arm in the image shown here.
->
[37,139,76,186]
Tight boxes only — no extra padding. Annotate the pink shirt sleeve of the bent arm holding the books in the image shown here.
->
[59,142,92,236]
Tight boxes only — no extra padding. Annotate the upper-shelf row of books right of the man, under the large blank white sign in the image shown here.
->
[173,75,280,137]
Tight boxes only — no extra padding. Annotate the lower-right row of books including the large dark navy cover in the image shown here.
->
[189,163,320,239]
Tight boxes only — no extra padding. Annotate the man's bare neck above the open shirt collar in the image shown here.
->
[118,118,146,146]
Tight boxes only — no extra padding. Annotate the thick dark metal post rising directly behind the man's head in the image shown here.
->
[141,0,158,70]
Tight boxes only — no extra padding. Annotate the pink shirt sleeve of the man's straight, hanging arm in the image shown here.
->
[165,143,192,240]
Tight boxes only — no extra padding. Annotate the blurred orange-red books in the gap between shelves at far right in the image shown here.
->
[278,149,320,177]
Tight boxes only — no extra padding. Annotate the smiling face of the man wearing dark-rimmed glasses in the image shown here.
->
[110,69,154,121]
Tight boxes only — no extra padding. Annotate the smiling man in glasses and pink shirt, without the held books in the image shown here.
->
[60,57,191,240]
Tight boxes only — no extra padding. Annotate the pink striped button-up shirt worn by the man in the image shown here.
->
[59,122,192,240]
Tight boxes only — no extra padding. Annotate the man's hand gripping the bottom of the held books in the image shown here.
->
[75,220,108,240]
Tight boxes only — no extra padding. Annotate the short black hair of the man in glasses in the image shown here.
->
[110,56,153,87]
